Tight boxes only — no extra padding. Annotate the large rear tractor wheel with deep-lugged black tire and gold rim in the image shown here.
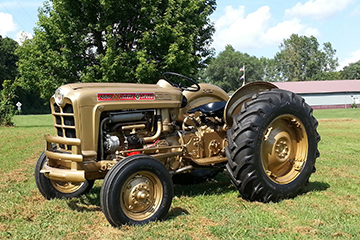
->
[225,89,320,202]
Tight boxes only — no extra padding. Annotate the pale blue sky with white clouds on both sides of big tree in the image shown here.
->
[0,0,360,69]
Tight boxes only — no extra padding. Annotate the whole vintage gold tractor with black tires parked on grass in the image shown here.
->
[35,72,320,227]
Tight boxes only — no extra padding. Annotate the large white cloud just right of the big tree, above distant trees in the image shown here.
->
[213,6,320,52]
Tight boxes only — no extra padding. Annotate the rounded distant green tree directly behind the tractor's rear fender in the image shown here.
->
[205,45,264,92]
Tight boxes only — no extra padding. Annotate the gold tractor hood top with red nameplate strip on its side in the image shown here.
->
[53,80,182,109]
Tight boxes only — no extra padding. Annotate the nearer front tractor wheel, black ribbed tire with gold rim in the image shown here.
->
[100,154,173,227]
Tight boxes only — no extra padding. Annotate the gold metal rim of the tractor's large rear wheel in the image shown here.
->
[261,114,308,184]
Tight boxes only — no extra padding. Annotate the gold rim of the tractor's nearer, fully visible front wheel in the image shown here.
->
[120,171,163,221]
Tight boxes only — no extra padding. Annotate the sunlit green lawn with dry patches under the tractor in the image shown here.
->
[0,109,360,239]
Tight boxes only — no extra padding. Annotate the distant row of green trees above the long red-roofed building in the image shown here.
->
[202,34,354,92]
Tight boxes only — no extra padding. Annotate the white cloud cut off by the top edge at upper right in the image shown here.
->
[285,0,354,20]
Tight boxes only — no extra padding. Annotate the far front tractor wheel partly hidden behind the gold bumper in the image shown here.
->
[34,152,94,199]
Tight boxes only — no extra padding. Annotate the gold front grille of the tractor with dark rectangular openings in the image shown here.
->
[53,103,76,150]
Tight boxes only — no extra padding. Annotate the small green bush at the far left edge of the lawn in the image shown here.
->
[0,80,16,126]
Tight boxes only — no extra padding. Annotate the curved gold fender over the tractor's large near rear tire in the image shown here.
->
[224,82,278,127]
